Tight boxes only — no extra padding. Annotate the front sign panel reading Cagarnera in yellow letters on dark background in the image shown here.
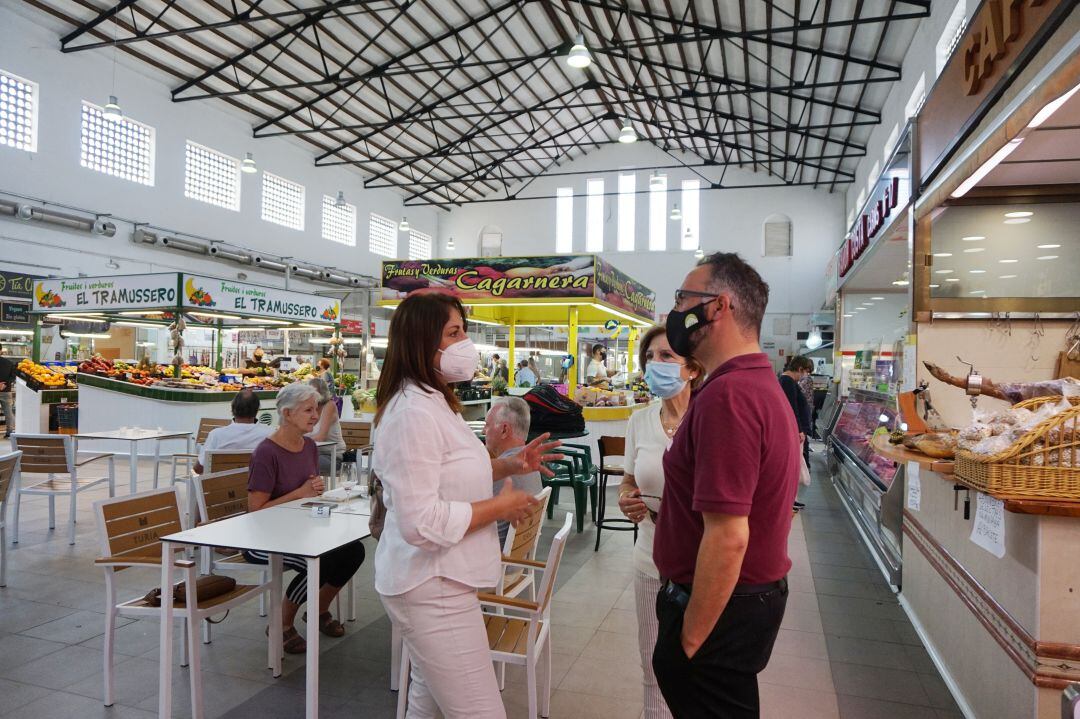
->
[382,255,596,302]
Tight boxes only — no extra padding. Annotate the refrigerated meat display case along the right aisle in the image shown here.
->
[827,390,904,589]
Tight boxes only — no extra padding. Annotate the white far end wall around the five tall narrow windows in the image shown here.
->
[436,143,843,328]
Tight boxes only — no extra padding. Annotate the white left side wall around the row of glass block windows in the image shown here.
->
[0,4,440,286]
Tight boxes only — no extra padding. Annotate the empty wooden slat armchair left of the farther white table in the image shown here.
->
[11,434,117,544]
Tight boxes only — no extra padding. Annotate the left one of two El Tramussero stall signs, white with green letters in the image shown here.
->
[33,273,176,312]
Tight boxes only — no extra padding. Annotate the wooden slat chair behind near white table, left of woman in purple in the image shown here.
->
[191,466,270,645]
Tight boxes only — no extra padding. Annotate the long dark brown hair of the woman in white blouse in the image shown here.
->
[375,293,465,424]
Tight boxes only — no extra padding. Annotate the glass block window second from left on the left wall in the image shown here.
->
[79,101,153,186]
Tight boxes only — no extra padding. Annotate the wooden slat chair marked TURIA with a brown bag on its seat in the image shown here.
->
[94,487,281,717]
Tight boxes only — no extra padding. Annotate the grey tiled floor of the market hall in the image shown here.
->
[0,444,960,719]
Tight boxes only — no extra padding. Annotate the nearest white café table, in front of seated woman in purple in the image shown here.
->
[158,500,372,719]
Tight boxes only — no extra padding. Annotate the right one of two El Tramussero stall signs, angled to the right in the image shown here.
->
[183,274,341,324]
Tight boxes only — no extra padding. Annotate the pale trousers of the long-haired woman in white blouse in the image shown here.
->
[380,576,507,719]
